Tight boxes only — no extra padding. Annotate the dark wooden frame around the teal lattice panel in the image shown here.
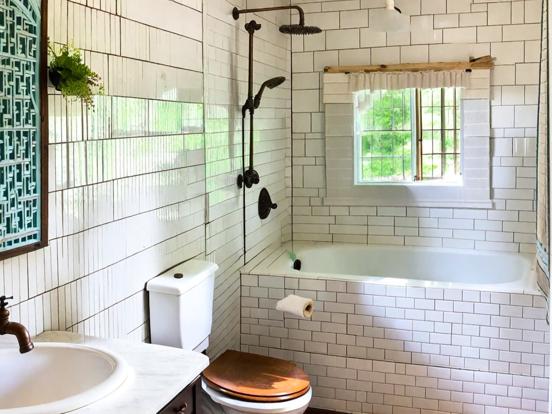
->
[0,0,48,260]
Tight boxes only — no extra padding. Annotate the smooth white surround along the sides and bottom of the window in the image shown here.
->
[323,70,493,208]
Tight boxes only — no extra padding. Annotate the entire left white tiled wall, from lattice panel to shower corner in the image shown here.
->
[0,0,291,355]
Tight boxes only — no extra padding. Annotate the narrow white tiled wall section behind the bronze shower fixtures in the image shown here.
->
[203,0,291,356]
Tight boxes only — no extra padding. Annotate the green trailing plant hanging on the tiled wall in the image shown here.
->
[48,43,104,108]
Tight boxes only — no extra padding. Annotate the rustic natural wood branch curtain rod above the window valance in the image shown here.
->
[324,56,494,73]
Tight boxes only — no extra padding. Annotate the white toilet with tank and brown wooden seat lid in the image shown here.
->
[147,260,312,414]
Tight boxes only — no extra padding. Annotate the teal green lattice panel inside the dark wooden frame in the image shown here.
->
[0,0,40,252]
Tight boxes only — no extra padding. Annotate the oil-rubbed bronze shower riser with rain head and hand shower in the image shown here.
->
[232,6,322,188]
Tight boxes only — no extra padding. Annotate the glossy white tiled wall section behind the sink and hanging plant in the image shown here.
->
[0,0,206,340]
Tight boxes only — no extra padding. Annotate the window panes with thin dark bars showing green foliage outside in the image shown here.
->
[355,88,462,184]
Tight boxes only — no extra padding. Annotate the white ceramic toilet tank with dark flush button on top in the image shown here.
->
[147,260,218,352]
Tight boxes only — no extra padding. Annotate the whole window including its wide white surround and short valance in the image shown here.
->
[324,69,493,208]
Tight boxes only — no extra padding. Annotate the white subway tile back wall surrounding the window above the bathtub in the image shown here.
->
[293,0,542,252]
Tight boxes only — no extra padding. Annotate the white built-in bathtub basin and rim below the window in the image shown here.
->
[253,243,540,295]
